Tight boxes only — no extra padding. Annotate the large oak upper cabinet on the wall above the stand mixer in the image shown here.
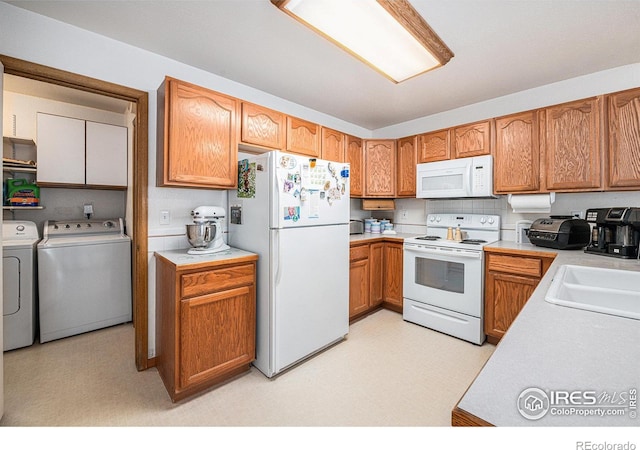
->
[157,77,239,189]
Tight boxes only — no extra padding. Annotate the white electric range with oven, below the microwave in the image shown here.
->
[403,213,500,345]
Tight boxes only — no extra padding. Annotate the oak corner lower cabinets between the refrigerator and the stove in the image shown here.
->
[349,240,402,321]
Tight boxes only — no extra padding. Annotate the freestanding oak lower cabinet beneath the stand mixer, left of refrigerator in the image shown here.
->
[156,254,257,402]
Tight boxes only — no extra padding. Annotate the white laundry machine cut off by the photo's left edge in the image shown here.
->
[2,220,40,351]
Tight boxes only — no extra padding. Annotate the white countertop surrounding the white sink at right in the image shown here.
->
[458,241,640,427]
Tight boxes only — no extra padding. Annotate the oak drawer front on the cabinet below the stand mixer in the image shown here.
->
[181,264,254,298]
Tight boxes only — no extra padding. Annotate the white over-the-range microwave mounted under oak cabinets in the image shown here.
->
[416,155,493,198]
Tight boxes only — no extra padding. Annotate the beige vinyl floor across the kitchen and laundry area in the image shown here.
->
[0,310,495,427]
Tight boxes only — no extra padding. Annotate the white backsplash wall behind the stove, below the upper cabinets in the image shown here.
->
[351,191,640,241]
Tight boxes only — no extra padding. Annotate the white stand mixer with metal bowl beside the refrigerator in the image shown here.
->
[187,206,230,255]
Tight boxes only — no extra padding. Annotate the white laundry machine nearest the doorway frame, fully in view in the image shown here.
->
[38,219,132,343]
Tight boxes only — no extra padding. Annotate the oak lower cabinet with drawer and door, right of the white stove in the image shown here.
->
[484,250,555,344]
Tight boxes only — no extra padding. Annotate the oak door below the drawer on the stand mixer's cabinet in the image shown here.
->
[179,286,256,389]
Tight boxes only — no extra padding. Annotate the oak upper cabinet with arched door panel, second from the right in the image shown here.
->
[543,98,602,191]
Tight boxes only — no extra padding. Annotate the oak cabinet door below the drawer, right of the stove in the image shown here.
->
[484,271,540,343]
